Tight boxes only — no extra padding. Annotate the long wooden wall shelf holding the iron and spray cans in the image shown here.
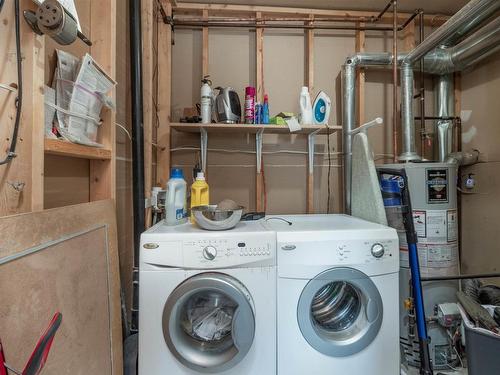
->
[170,123,342,134]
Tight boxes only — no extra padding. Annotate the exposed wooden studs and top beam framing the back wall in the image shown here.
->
[149,0,447,213]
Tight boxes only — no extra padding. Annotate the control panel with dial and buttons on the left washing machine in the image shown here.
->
[182,237,276,267]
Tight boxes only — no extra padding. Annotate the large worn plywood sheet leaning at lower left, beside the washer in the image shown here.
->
[0,201,122,375]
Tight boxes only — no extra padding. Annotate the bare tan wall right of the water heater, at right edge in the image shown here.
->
[460,53,500,273]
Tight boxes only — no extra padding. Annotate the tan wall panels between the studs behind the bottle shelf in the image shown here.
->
[172,28,433,213]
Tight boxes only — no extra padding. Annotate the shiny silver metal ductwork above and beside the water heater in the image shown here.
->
[342,0,500,212]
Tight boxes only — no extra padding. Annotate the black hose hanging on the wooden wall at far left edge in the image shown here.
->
[0,0,23,165]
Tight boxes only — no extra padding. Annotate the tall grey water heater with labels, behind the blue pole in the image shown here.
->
[384,163,460,369]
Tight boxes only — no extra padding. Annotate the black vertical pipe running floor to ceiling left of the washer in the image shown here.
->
[129,0,145,332]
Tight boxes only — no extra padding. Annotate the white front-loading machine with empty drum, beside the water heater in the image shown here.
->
[266,215,400,375]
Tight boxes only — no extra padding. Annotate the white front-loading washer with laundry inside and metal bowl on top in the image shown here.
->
[139,221,276,375]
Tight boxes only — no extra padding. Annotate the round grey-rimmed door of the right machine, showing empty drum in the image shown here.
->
[297,267,382,357]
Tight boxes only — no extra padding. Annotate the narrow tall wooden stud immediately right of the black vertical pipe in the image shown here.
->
[141,1,157,228]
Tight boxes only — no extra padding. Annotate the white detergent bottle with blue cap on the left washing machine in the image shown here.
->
[165,168,187,225]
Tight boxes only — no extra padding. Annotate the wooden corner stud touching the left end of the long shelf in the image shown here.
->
[156,0,172,186]
